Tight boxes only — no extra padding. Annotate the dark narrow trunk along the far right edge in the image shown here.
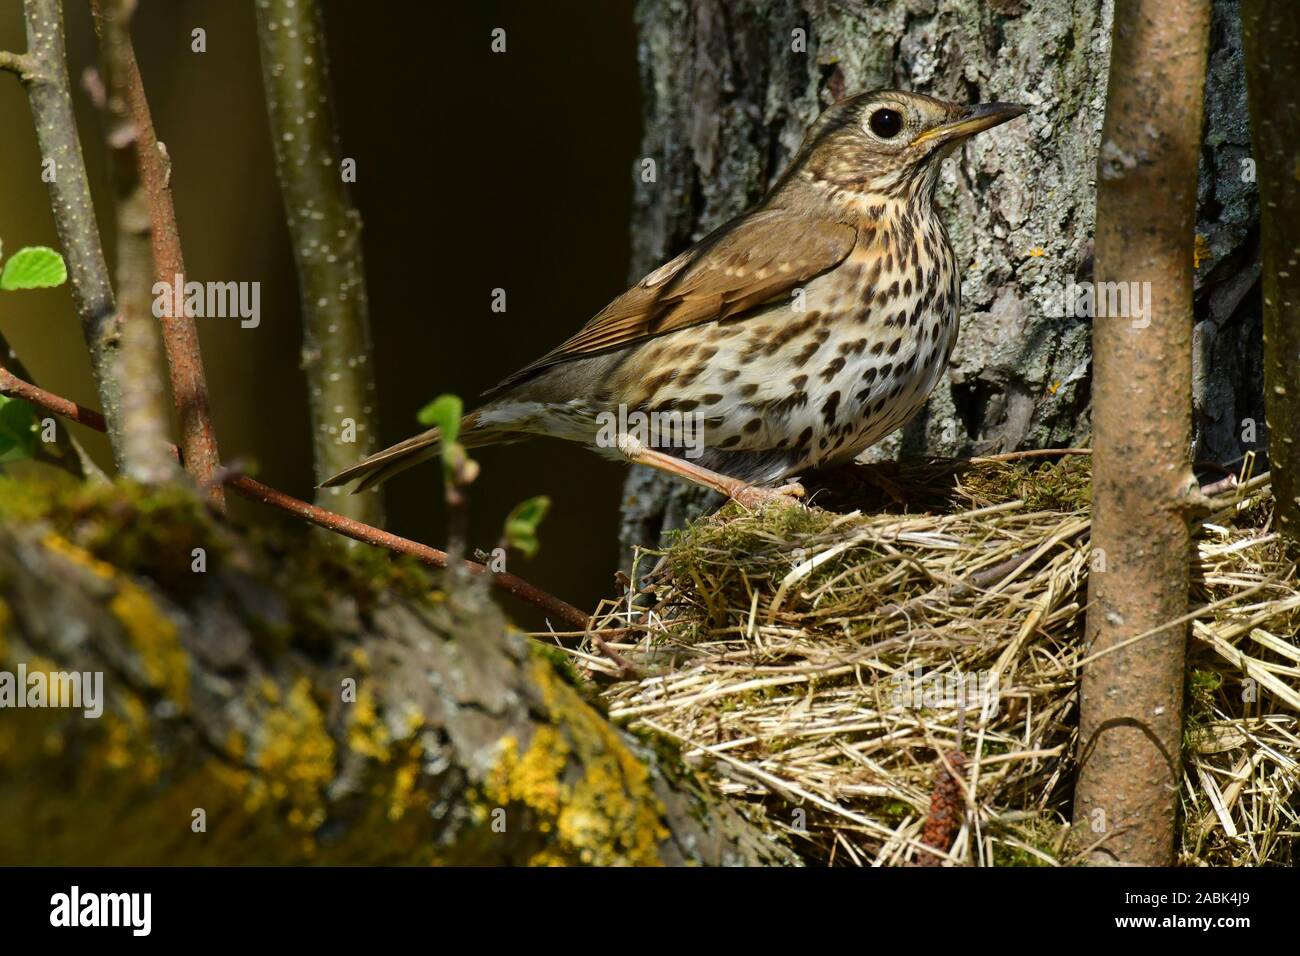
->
[1242,0,1300,553]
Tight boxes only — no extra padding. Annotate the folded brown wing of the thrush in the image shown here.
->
[485,208,858,394]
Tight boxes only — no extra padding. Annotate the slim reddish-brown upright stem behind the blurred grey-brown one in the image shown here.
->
[91,0,225,510]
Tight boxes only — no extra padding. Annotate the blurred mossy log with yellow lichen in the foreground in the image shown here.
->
[0,480,796,865]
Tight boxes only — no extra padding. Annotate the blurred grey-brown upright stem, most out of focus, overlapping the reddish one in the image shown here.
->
[82,0,178,484]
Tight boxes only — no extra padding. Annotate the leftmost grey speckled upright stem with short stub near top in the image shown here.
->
[0,0,127,471]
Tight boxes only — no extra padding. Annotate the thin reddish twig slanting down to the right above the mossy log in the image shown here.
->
[0,368,599,632]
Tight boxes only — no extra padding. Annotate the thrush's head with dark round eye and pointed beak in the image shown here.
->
[793,90,1026,198]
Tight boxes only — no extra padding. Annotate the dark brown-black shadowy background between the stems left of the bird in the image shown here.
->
[0,0,641,624]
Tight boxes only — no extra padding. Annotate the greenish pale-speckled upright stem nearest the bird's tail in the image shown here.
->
[255,0,384,524]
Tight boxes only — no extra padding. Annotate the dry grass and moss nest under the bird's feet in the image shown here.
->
[576,455,1300,866]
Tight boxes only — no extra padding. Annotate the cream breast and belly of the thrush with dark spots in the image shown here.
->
[585,211,958,476]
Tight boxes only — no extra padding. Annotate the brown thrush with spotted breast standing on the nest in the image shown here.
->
[322,90,1026,505]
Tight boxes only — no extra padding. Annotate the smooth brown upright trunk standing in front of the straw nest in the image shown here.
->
[1074,0,1210,866]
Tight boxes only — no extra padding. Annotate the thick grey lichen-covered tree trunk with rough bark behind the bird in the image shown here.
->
[621,0,1264,564]
